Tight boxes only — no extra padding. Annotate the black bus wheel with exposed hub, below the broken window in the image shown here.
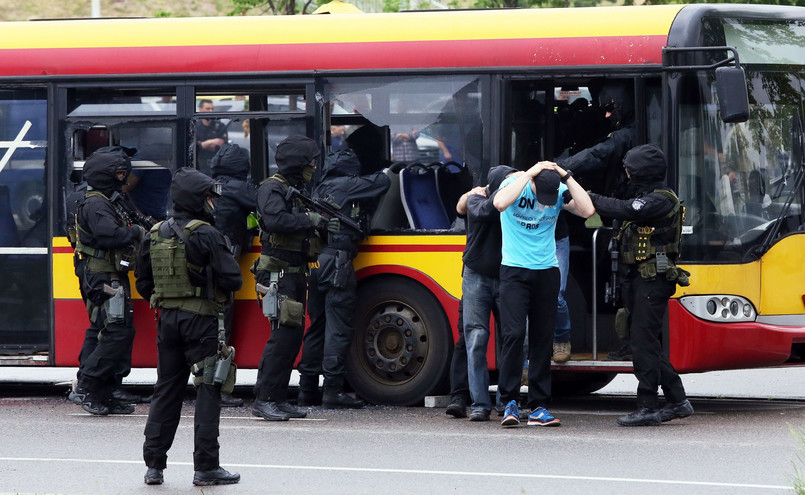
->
[347,279,452,405]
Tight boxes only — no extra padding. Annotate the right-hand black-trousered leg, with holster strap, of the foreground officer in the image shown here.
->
[179,312,221,471]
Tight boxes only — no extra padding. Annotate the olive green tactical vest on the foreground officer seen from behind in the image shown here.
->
[151,220,227,316]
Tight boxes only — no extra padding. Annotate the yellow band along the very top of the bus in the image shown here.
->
[0,5,683,49]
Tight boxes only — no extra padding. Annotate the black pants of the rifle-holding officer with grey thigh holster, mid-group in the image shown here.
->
[254,270,307,402]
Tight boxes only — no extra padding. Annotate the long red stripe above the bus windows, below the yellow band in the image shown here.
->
[0,35,667,76]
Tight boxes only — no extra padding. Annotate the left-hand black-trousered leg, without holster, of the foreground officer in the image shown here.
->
[143,309,190,469]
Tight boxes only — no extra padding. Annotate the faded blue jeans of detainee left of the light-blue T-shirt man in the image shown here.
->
[461,266,500,412]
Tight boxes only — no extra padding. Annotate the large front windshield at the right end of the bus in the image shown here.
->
[679,70,803,263]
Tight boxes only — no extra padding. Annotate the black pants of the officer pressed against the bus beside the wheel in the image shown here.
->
[298,251,357,391]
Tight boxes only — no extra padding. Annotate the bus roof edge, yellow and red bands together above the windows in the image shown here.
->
[0,5,682,76]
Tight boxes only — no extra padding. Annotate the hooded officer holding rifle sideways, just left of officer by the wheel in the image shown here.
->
[252,135,339,421]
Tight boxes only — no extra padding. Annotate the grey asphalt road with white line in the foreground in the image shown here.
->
[0,384,805,495]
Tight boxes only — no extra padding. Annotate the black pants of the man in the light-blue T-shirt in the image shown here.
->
[498,266,560,409]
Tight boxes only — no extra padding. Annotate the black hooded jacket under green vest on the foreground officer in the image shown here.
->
[135,167,243,300]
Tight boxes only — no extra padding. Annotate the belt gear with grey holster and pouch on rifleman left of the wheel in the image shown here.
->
[252,254,308,327]
